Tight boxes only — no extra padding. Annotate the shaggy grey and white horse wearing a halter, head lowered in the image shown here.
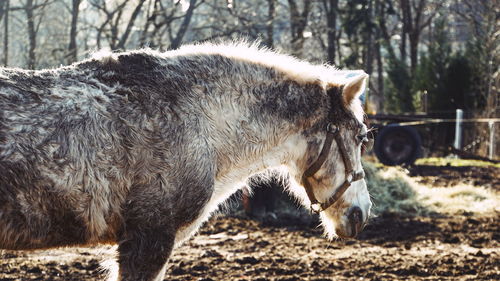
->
[0,44,371,280]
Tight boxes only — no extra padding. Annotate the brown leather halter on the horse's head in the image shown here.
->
[302,123,365,214]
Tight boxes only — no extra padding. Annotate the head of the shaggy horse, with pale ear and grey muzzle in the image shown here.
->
[297,73,372,239]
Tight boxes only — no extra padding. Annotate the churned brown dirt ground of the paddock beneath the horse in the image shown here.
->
[0,163,500,281]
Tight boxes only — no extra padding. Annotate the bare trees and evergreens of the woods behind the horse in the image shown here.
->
[0,0,500,117]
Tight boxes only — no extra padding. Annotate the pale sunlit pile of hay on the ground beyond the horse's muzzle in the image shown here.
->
[363,162,500,215]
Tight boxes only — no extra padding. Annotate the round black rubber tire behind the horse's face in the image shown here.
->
[374,124,422,166]
